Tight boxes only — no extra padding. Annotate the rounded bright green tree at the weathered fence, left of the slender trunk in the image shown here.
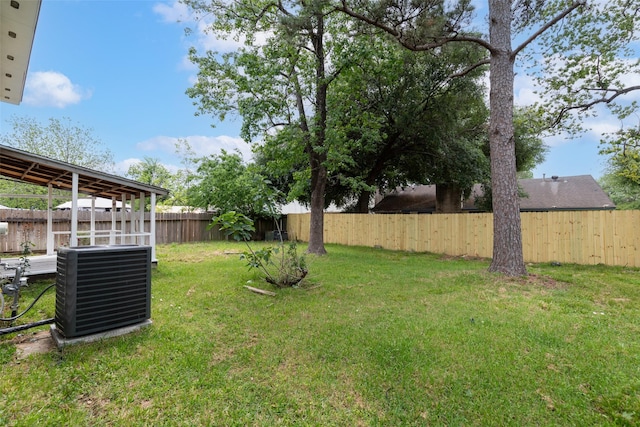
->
[188,150,277,220]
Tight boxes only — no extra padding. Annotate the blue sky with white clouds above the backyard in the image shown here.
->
[0,0,632,178]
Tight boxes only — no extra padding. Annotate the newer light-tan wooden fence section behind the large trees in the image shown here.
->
[287,210,640,267]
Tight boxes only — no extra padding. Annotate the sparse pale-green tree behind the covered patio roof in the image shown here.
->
[0,116,114,209]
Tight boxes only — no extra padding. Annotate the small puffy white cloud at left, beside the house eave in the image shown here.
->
[24,71,91,108]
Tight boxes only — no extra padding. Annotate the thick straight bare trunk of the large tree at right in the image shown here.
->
[489,0,527,276]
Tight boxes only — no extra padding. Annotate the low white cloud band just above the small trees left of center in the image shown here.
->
[136,135,252,161]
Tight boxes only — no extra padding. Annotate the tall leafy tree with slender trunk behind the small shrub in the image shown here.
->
[185,0,364,254]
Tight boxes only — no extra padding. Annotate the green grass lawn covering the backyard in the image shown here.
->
[0,243,640,426]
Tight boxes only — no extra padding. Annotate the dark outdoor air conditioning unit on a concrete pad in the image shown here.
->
[55,245,151,338]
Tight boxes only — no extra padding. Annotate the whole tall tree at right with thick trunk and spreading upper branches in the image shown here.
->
[337,0,640,276]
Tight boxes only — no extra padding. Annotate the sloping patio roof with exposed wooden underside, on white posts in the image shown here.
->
[0,145,169,199]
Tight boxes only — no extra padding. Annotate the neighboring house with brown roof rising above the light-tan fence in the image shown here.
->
[372,175,616,213]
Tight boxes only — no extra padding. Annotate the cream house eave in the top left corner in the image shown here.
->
[0,0,41,105]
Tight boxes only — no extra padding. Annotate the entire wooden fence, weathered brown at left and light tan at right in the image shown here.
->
[6,209,640,267]
